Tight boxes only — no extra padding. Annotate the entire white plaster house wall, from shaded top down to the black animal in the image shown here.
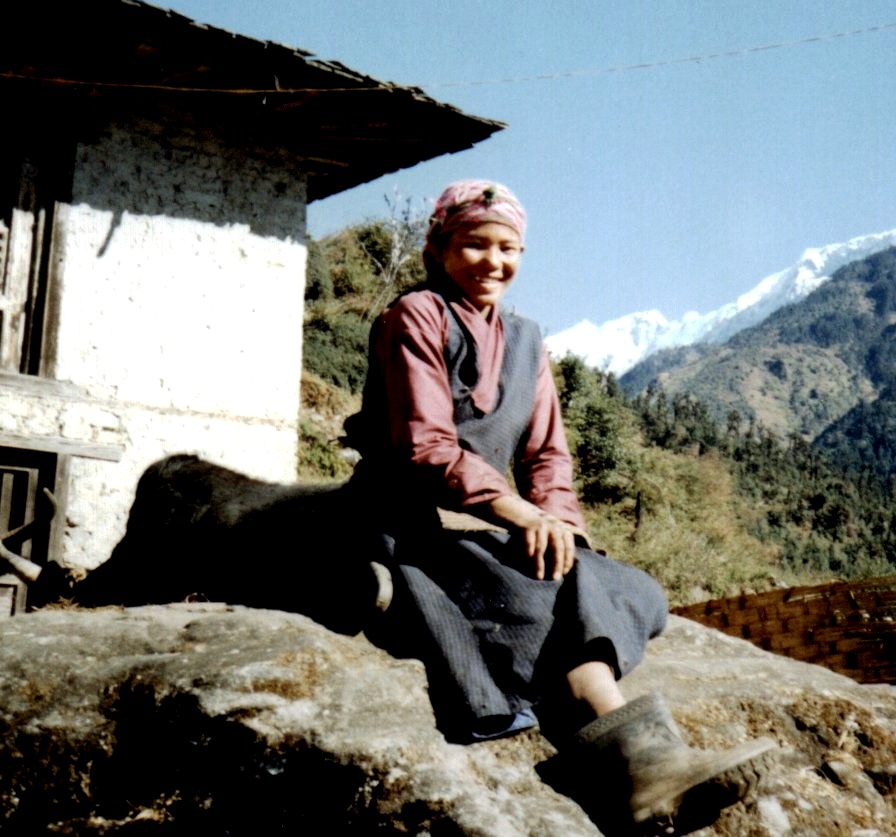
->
[24,119,306,567]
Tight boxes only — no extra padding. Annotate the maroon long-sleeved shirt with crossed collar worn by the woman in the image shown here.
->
[373,284,584,528]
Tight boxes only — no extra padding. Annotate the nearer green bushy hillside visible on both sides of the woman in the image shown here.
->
[300,219,896,603]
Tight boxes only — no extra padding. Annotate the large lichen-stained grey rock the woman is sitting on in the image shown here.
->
[0,604,896,837]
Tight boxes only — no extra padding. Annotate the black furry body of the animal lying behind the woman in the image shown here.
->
[73,454,377,633]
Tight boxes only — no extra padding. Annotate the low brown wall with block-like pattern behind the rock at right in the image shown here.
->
[673,576,896,683]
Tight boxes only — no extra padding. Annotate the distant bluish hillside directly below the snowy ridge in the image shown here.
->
[622,248,896,485]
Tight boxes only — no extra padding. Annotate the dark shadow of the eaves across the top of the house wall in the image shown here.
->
[6,89,307,246]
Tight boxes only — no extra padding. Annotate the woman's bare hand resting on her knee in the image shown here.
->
[485,496,578,581]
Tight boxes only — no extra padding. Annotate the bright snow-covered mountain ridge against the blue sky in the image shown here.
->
[545,229,896,375]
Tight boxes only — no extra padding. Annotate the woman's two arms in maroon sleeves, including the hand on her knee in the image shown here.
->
[375,294,582,579]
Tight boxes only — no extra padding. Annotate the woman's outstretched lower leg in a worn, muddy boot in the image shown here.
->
[556,578,774,833]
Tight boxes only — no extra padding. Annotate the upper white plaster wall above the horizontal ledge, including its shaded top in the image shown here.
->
[55,126,306,421]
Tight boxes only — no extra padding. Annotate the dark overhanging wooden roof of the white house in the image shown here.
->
[0,0,504,200]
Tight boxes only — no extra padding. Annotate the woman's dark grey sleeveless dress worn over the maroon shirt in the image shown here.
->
[353,290,668,737]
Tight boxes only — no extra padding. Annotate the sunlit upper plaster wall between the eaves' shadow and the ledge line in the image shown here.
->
[56,204,305,423]
